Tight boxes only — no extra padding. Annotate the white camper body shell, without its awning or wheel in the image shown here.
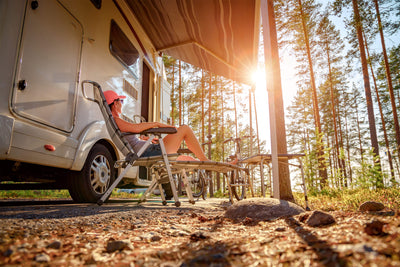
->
[0,0,170,201]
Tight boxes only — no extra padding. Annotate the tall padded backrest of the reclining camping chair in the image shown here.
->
[84,81,135,155]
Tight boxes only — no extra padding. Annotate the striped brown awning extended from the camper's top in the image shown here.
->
[125,0,260,83]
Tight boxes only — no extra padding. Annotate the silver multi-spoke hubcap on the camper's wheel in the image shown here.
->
[90,155,111,194]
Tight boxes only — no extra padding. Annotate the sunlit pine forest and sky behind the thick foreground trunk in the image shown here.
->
[164,0,400,197]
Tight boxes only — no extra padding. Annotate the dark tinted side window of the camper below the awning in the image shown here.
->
[110,20,140,79]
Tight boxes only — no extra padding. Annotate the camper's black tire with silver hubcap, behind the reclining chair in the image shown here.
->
[69,144,116,203]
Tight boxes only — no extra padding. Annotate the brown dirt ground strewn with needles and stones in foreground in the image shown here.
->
[0,199,400,266]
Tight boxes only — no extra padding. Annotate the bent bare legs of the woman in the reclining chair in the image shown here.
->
[164,125,209,161]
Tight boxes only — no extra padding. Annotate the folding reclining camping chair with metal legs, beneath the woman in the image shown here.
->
[82,80,194,207]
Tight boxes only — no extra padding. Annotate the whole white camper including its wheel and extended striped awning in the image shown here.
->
[0,0,260,202]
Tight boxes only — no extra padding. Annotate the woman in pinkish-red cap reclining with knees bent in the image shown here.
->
[104,90,209,161]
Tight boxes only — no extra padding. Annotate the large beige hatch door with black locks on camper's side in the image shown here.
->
[12,0,83,132]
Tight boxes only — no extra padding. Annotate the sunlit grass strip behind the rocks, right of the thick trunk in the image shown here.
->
[294,188,400,211]
